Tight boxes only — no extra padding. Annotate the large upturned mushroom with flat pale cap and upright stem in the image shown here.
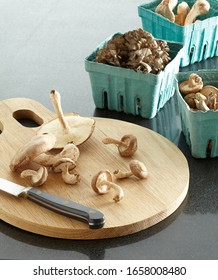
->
[38,90,95,148]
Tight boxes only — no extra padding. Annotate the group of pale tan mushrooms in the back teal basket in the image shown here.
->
[155,0,210,26]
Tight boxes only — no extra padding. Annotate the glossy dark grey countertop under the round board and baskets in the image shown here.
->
[0,0,218,260]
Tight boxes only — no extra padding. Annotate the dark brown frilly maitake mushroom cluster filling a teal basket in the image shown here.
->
[95,28,170,74]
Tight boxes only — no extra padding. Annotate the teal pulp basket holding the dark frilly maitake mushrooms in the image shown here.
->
[85,33,183,119]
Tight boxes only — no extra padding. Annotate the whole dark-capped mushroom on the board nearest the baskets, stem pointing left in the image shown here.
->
[102,134,138,157]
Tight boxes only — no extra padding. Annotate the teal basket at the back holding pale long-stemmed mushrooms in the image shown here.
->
[138,0,218,67]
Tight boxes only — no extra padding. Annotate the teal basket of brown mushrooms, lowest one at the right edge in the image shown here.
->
[175,70,218,158]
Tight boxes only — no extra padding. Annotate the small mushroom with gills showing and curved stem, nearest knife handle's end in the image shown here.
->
[91,170,124,202]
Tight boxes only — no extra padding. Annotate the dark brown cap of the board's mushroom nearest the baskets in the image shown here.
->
[118,134,138,157]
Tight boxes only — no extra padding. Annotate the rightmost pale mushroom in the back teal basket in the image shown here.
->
[184,0,210,25]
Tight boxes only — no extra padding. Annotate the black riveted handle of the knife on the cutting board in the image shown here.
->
[26,188,104,229]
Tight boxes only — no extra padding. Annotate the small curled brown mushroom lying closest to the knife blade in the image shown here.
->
[20,166,48,187]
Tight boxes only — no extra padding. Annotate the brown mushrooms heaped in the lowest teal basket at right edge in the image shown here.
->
[179,73,218,112]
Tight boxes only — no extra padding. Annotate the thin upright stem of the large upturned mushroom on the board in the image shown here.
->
[50,90,70,131]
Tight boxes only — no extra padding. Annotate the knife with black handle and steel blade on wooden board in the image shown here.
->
[0,178,105,229]
